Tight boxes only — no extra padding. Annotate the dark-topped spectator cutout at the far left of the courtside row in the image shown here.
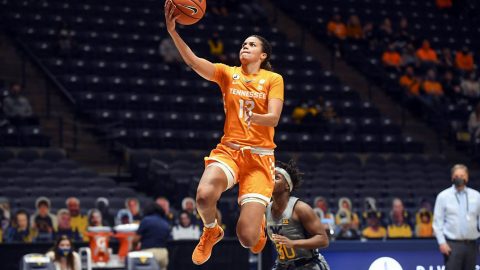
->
[4,209,36,243]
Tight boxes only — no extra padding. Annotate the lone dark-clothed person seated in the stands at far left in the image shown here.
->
[3,83,33,124]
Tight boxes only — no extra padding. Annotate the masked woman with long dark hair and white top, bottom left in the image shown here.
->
[46,235,82,270]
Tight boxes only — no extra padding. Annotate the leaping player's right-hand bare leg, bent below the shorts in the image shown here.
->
[237,201,266,250]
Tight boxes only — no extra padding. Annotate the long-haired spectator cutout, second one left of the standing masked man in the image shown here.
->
[387,198,413,238]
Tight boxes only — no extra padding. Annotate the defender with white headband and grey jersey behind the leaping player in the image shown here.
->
[267,161,330,270]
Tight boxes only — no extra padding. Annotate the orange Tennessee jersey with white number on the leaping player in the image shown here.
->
[212,64,284,149]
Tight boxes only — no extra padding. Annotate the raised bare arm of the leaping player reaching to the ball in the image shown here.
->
[165,1,215,80]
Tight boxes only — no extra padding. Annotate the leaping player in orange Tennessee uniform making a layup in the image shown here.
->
[165,1,283,265]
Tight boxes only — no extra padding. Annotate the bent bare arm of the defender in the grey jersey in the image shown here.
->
[273,201,329,249]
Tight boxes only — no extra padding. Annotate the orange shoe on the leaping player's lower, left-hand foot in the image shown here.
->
[192,224,223,265]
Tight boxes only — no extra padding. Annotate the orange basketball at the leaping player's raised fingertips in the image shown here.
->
[172,0,207,25]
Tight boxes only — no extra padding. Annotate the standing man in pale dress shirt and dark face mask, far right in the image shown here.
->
[433,164,480,270]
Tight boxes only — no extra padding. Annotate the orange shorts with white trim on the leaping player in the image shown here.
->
[205,143,275,206]
